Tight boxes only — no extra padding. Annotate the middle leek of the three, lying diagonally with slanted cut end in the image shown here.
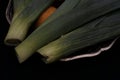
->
[15,0,120,62]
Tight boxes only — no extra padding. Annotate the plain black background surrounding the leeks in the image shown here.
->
[0,0,120,80]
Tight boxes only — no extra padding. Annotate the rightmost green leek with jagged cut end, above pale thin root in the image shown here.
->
[38,11,120,63]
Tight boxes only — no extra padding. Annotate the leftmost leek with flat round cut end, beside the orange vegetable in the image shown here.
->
[5,0,54,46]
